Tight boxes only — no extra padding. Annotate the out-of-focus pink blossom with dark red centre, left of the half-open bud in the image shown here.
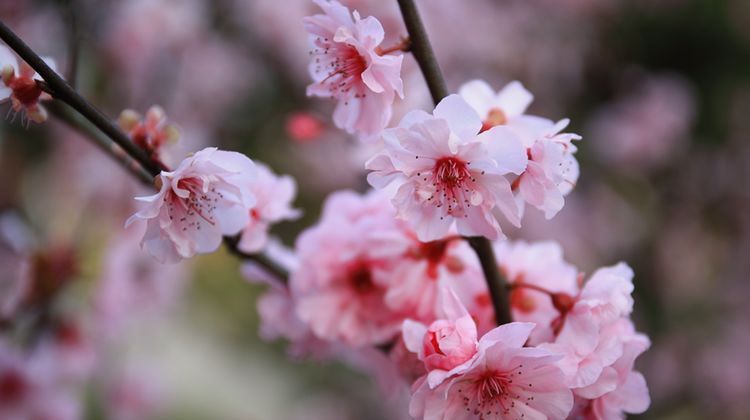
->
[290,191,408,346]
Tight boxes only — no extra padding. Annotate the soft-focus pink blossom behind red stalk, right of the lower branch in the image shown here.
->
[494,241,578,345]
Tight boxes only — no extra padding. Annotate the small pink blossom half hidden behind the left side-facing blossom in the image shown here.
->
[238,164,300,252]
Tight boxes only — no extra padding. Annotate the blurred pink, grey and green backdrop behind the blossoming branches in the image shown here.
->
[0,0,750,420]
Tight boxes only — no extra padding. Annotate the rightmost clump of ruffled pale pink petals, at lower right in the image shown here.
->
[542,263,650,418]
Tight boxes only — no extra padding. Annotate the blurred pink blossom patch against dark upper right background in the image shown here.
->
[587,75,696,170]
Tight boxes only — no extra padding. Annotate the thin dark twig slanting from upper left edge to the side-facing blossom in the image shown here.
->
[0,20,162,176]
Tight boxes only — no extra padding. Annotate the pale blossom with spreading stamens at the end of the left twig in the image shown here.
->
[126,147,255,262]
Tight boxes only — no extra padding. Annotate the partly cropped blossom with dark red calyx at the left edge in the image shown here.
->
[0,45,55,123]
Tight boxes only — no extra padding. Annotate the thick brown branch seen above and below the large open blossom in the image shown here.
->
[398,0,512,324]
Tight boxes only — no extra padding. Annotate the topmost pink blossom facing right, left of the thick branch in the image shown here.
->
[303,0,404,138]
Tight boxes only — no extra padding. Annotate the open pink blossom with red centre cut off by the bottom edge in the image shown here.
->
[409,322,573,420]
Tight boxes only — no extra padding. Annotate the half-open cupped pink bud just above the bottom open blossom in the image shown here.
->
[402,288,478,385]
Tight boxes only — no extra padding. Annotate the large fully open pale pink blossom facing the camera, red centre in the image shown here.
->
[366,95,527,241]
